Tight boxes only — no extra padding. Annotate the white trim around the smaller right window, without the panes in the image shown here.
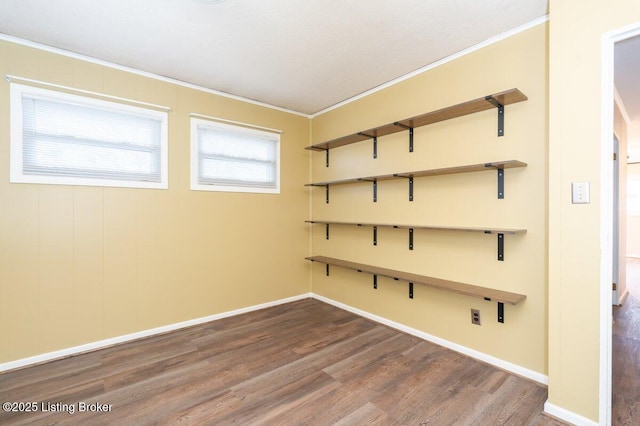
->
[191,114,282,194]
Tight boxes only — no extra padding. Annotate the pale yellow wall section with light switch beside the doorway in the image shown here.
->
[549,0,640,421]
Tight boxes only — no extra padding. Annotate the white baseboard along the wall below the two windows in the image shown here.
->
[0,293,313,372]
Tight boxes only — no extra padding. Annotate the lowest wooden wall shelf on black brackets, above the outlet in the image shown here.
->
[305,256,527,322]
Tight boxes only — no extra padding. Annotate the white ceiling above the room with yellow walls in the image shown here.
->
[0,0,547,114]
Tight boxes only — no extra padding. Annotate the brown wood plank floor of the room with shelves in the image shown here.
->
[0,299,564,426]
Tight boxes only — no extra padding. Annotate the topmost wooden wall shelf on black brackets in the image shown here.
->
[306,89,528,151]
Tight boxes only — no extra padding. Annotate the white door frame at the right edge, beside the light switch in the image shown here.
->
[599,22,640,425]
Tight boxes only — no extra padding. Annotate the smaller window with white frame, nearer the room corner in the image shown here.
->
[191,117,280,194]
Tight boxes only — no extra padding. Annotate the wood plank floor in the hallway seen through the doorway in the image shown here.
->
[611,259,640,426]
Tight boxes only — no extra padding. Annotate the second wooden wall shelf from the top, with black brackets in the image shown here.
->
[305,160,527,203]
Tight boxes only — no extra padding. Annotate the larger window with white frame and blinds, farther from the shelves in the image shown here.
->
[11,84,168,188]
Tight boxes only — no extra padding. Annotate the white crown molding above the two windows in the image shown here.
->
[0,33,310,118]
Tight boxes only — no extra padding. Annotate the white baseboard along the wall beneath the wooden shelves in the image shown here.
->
[312,293,549,385]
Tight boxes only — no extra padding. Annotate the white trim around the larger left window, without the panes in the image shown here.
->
[9,83,169,189]
